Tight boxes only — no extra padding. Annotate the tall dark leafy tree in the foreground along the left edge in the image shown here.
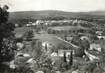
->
[0,5,15,64]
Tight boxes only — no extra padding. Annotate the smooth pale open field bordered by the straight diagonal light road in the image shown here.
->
[34,34,79,49]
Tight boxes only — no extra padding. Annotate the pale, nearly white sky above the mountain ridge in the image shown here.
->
[0,0,105,12]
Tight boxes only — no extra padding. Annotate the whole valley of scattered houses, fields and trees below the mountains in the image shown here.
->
[7,19,105,73]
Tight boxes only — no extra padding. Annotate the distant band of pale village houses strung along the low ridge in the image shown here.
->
[15,19,93,27]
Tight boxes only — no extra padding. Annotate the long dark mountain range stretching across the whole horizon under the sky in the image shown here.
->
[9,10,105,22]
